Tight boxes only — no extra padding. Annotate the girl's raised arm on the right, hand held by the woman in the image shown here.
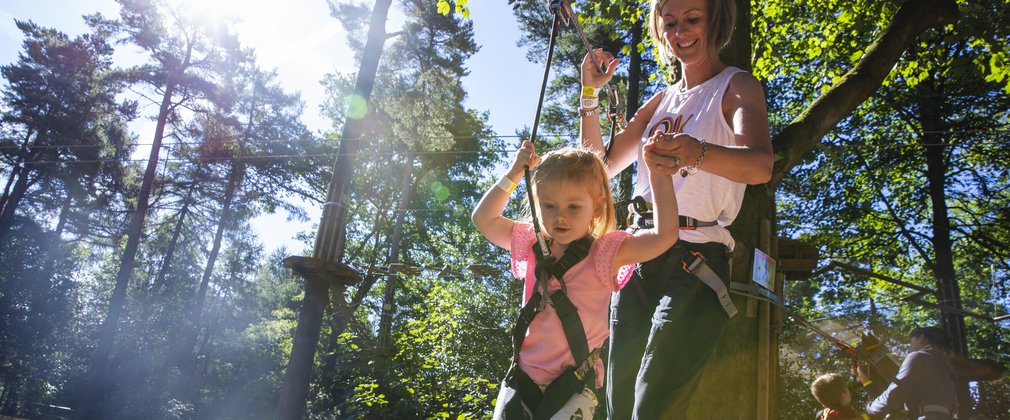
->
[613,132,681,273]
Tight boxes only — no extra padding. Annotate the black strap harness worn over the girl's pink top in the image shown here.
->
[503,236,600,420]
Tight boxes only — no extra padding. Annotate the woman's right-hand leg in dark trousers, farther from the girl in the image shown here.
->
[634,242,729,419]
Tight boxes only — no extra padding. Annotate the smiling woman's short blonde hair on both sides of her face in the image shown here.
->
[648,0,736,66]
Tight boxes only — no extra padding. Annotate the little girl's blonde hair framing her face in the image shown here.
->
[531,147,617,237]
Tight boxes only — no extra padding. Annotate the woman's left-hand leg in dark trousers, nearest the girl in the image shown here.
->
[606,255,666,420]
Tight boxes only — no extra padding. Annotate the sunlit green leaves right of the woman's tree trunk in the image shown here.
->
[754,2,1010,417]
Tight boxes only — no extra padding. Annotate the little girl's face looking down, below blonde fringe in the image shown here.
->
[536,181,601,244]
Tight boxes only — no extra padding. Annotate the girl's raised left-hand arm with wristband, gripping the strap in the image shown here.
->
[470,140,541,249]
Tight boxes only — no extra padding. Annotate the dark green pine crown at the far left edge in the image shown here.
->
[0,21,134,241]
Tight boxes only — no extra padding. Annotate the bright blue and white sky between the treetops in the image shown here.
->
[0,0,543,251]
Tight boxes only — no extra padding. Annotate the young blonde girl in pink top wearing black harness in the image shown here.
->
[472,138,679,419]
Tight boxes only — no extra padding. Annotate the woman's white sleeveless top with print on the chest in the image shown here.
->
[634,67,746,249]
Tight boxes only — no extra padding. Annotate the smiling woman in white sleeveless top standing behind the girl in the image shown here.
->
[580,0,774,419]
